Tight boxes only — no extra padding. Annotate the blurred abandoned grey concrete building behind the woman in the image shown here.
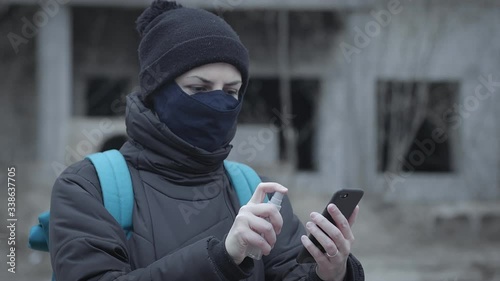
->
[0,0,500,280]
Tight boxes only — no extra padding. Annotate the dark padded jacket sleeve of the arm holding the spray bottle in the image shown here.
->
[49,160,251,281]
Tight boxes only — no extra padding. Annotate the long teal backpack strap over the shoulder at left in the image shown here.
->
[86,149,134,237]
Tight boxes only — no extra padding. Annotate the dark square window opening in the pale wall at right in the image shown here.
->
[377,80,459,173]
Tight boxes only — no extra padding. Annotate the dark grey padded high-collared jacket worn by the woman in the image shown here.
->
[50,94,364,281]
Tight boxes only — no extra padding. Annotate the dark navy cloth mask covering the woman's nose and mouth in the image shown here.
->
[153,83,241,152]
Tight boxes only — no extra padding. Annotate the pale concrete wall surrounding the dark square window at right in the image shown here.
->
[319,1,500,200]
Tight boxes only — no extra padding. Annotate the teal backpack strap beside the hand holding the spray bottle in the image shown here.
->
[224,160,267,206]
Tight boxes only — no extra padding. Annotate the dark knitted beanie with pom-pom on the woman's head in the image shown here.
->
[136,0,249,99]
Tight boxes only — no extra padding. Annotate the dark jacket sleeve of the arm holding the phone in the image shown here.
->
[263,192,364,281]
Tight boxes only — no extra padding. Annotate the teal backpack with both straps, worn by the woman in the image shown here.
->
[28,150,267,252]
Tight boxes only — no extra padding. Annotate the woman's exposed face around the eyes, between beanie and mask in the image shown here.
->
[175,63,242,99]
